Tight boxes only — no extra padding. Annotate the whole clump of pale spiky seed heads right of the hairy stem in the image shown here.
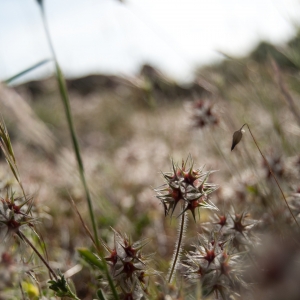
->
[182,212,257,299]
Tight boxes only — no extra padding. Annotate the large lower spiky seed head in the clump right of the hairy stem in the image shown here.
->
[182,232,243,299]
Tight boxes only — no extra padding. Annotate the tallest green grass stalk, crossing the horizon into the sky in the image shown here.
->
[38,1,100,250]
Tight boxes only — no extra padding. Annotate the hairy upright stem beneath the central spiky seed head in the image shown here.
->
[168,206,187,283]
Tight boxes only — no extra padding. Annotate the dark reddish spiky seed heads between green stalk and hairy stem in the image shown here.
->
[103,230,156,300]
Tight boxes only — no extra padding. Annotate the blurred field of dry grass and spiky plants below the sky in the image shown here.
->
[0,27,300,300]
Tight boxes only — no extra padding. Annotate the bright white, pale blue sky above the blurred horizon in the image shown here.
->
[0,0,300,82]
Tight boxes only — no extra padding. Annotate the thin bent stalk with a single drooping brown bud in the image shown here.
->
[231,123,300,228]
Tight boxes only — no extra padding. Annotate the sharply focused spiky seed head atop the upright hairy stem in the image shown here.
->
[155,156,217,220]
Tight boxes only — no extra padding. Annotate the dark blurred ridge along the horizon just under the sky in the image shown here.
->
[11,31,300,99]
